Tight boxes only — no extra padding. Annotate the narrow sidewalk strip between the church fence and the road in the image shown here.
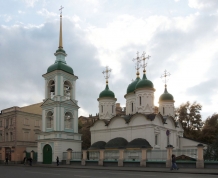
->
[0,164,218,175]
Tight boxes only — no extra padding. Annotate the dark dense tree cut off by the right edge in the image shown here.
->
[201,114,218,144]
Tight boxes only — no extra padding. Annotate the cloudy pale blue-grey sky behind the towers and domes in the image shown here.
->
[0,0,218,119]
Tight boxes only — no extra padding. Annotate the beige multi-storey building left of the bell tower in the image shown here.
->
[0,103,42,162]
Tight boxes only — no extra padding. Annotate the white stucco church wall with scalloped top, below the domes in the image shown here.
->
[90,114,183,149]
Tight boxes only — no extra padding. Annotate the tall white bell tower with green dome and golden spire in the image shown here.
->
[38,11,82,164]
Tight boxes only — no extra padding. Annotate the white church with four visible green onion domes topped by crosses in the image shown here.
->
[89,54,201,154]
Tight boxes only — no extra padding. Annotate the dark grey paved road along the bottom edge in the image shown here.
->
[0,166,217,178]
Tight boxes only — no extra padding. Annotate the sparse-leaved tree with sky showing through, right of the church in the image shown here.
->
[176,101,203,140]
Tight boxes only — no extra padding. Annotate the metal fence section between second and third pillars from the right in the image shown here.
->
[147,150,167,161]
